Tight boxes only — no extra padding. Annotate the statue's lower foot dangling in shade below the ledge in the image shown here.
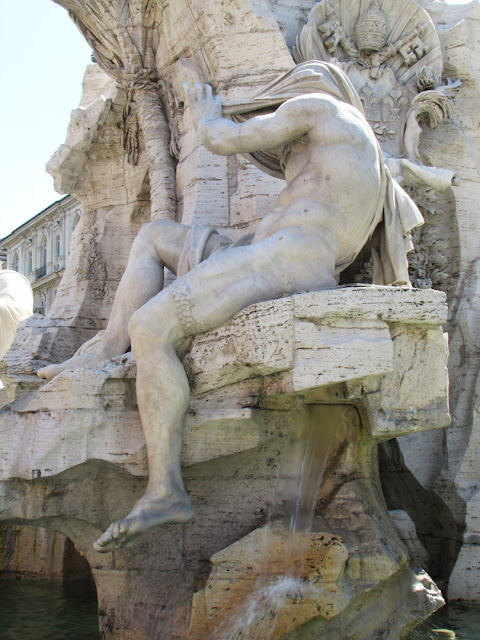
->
[93,494,193,553]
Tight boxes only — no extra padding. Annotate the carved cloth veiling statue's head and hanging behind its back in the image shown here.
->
[223,60,424,286]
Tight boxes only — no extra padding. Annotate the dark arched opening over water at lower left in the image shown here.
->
[0,525,100,640]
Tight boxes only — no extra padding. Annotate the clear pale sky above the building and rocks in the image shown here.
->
[0,0,469,238]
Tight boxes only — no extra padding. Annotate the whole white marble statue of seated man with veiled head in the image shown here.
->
[38,63,421,552]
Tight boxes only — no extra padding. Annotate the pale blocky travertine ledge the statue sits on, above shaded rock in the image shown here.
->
[0,287,449,480]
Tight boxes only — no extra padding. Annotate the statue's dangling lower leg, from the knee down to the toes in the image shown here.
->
[94,289,193,552]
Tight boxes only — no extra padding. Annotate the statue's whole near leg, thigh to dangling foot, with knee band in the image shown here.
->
[94,229,336,552]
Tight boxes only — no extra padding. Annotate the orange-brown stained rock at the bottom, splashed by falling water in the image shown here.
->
[187,529,443,640]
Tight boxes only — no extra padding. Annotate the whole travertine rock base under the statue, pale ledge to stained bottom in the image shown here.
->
[0,287,449,640]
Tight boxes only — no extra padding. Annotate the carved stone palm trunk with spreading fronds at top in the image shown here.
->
[53,0,177,220]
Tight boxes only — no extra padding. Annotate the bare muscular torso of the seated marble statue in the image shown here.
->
[251,99,383,253]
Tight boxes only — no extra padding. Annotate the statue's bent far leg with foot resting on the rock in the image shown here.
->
[37,221,189,380]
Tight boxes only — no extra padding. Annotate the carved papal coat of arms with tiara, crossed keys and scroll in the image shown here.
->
[293,0,460,191]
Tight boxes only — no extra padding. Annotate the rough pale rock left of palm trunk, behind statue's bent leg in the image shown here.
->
[1,65,149,401]
